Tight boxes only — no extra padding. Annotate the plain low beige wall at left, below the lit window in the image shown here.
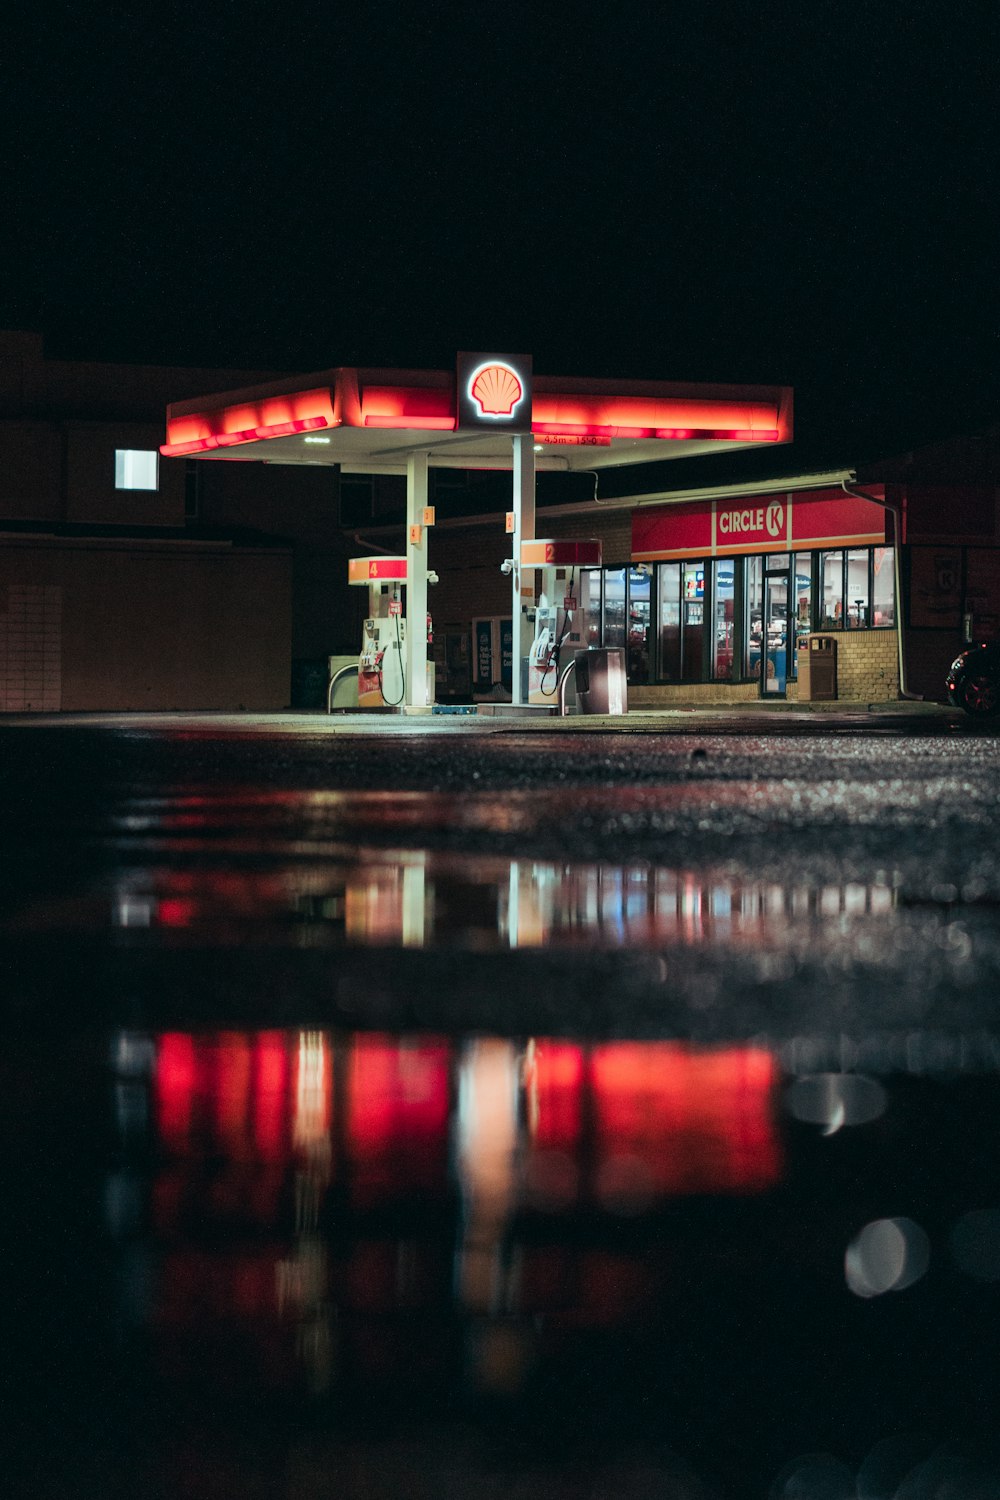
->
[0,539,291,711]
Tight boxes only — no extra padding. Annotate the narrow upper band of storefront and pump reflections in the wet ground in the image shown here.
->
[89,851,897,951]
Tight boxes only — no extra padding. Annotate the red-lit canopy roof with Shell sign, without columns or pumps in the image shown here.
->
[160,354,792,474]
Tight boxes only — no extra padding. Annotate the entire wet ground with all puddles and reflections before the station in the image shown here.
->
[0,705,1000,1500]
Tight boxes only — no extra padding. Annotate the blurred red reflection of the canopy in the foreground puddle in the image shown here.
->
[113,1031,781,1394]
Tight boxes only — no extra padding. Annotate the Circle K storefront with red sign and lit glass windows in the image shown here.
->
[589,476,901,707]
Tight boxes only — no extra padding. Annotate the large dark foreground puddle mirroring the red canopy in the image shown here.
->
[1,1028,1000,1500]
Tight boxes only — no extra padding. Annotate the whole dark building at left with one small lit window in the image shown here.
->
[0,332,342,713]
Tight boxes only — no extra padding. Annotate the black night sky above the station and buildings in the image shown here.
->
[0,0,1000,462]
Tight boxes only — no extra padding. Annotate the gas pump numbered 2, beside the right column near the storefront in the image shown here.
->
[522,540,601,705]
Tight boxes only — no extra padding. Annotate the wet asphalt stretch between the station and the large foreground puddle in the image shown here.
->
[0,710,1000,1040]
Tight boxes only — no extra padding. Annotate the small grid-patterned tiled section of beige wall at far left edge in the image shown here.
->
[0,584,63,713]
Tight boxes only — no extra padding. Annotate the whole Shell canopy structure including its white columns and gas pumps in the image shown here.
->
[160,353,792,711]
